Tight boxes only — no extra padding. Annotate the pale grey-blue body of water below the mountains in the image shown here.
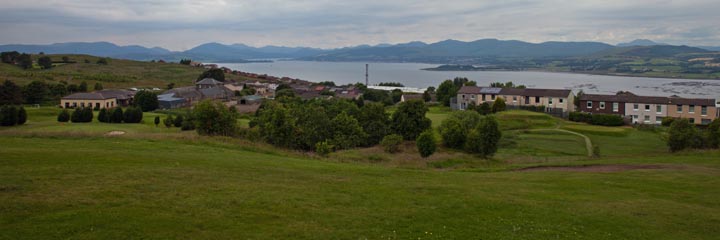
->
[218,61,720,98]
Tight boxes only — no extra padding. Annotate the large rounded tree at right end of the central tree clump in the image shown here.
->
[391,100,432,140]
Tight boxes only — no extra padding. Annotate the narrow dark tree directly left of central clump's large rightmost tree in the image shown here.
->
[357,103,390,146]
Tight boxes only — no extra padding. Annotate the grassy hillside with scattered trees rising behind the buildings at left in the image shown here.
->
[0,54,258,89]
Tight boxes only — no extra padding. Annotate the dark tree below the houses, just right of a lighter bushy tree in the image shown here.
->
[465,116,502,158]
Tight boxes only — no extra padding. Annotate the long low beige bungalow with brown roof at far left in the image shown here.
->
[60,89,135,109]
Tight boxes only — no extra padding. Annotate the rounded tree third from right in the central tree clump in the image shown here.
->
[330,112,367,149]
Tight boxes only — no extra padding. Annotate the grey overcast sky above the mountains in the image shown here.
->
[0,0,720,50]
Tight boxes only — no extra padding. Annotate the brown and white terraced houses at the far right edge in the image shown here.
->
[578,92,720,125]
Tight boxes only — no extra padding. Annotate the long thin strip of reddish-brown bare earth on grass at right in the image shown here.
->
[516,164,681,172]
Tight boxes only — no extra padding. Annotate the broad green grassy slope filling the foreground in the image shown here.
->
[0,109,720,239]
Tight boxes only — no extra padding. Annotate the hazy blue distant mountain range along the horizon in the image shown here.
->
[0,39,720,63]
